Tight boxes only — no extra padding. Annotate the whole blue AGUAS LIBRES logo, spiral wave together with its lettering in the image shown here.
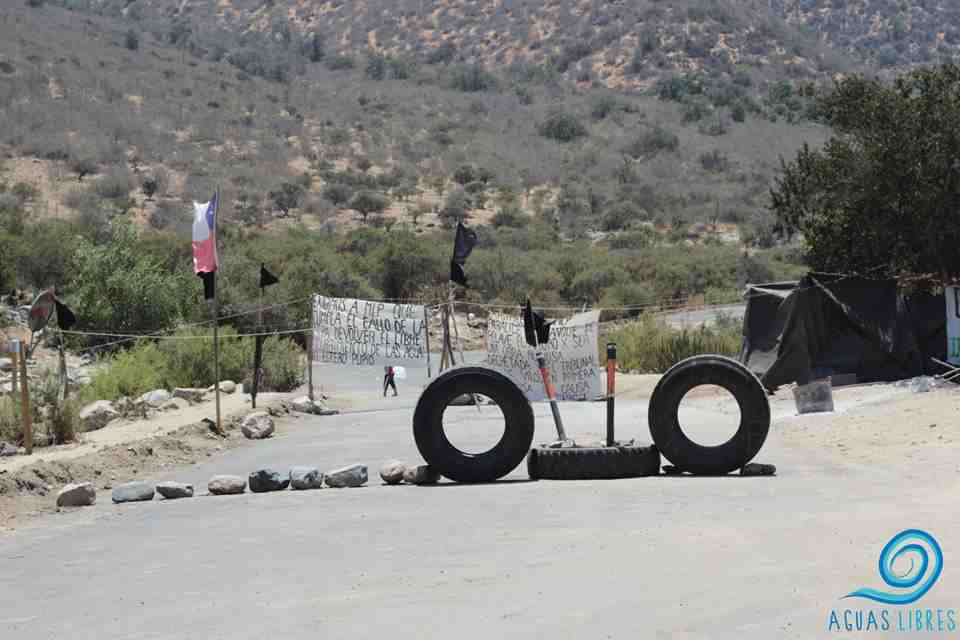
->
[827,529,957,633]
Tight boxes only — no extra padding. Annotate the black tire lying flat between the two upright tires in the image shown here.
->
[527,445,660,480]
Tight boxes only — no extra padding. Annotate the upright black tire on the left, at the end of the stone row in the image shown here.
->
[413,367,534,482]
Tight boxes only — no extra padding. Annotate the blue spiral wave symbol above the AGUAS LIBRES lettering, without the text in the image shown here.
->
[844,529,943,604]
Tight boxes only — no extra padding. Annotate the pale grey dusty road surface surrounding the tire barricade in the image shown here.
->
[0,378,960,640]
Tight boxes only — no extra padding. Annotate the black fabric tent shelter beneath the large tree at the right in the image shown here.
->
[740,273,947,391]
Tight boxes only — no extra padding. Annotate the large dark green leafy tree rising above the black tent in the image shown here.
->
[771,64,960,279]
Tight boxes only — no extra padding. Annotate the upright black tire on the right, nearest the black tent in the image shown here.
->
[648,355,770,475]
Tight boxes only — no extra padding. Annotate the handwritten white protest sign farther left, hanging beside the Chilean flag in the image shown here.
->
[311,295,427,365]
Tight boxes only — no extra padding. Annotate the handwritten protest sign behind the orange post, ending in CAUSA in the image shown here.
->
[486,311,601,401]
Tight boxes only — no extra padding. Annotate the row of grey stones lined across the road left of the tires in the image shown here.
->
[57,460,440,507]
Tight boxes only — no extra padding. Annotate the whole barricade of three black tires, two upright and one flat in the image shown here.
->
[413,355,770,482]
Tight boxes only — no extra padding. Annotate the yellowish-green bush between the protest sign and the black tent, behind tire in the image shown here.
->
[600,315,741,373]
